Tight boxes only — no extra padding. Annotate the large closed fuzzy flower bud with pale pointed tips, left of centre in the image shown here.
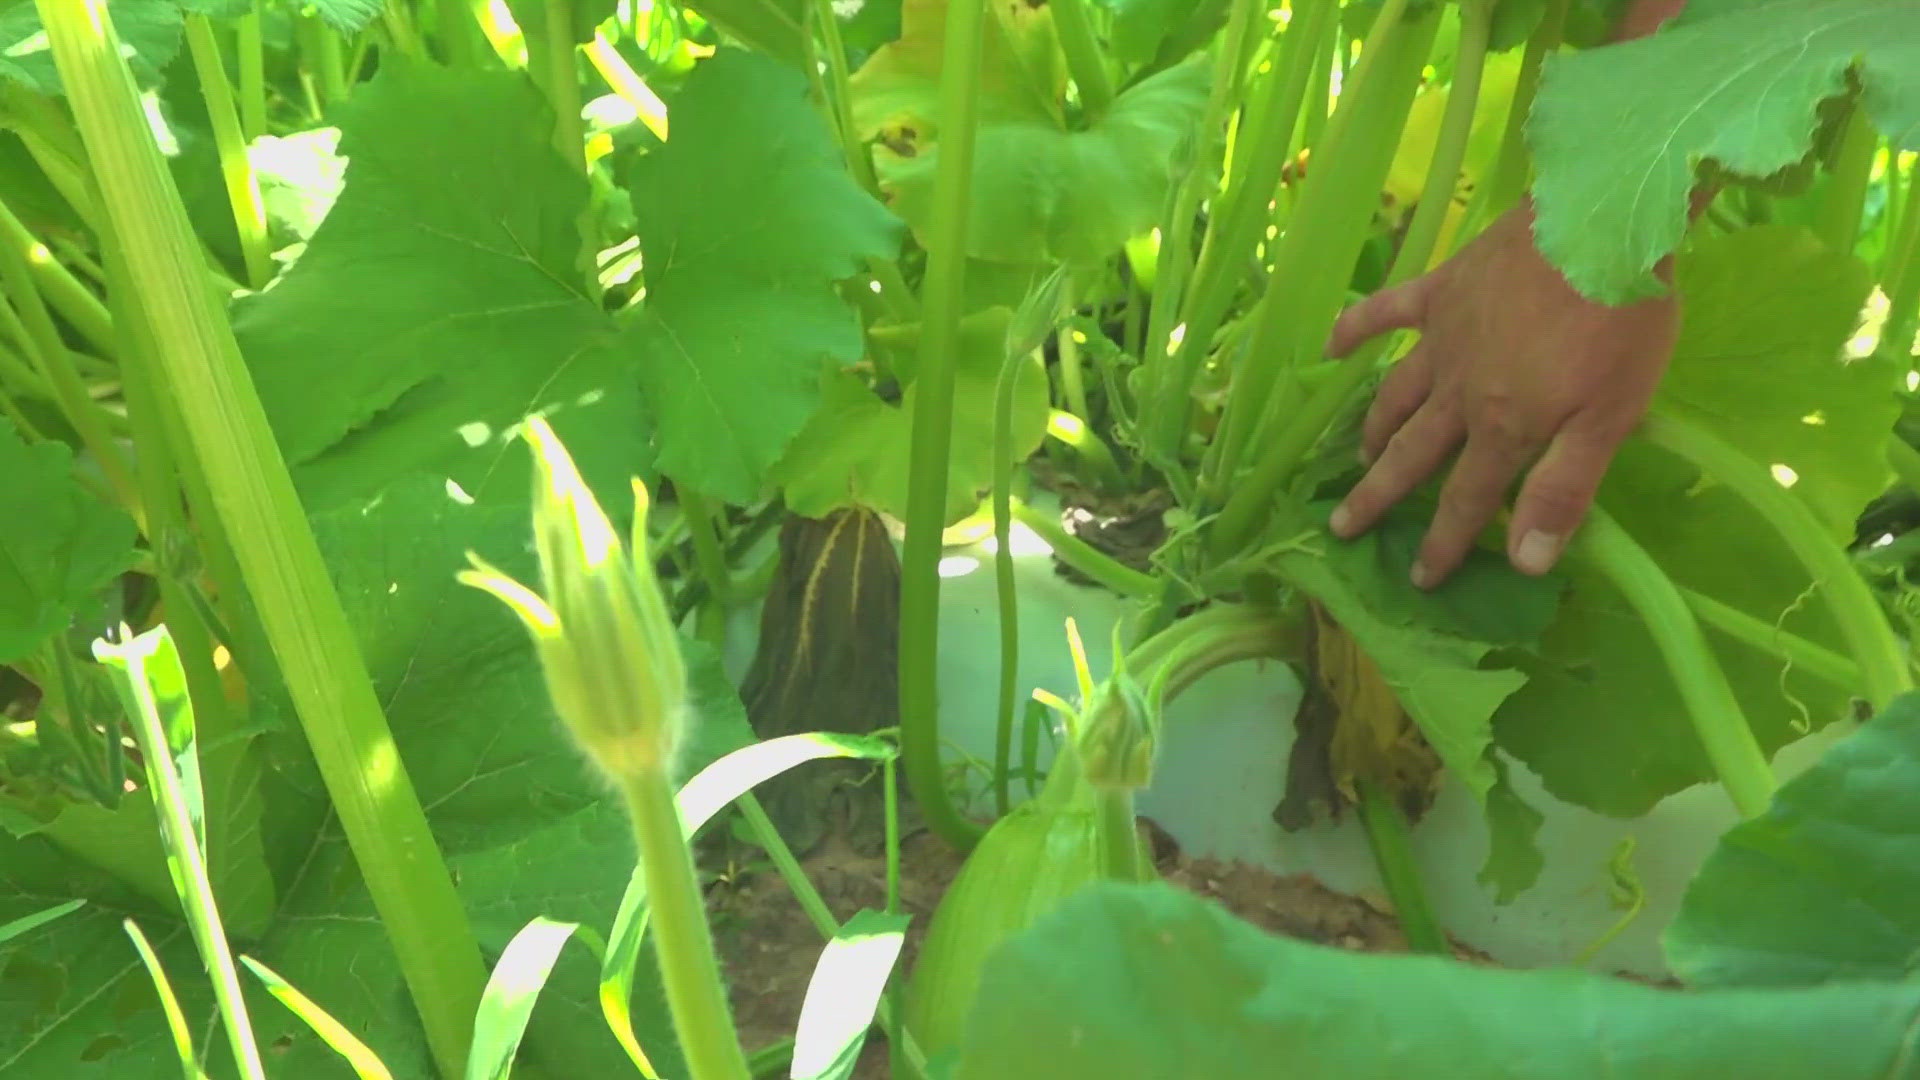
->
[459,417,687,778]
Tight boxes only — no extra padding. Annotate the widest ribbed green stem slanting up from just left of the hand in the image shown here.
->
[1212,2,1452,559]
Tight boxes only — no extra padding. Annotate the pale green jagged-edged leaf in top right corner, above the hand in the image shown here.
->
[1528,0,1920,304]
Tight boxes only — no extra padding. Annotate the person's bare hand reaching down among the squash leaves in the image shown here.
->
[1329,206,1680,588]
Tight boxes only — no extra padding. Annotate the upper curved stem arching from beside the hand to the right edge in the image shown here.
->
[1640,411,1914,711]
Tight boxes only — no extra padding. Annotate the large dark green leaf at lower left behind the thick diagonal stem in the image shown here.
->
[0,477,691,1080]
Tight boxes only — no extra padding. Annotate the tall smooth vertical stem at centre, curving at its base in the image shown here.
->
[900,2,987,849]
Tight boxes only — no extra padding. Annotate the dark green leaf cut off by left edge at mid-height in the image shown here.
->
[0,417,134,663]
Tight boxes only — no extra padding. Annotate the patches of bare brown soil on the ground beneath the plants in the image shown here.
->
[705,788,1492,1080]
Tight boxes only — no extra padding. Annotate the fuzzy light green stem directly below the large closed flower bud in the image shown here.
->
[624,769,749,1080]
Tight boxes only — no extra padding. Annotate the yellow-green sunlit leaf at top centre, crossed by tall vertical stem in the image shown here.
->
[851,0,1212,263]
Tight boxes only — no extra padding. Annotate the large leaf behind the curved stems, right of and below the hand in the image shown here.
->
[1496,229,1897,817]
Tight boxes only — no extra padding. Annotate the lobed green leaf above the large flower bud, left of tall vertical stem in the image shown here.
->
[626,48,900,503]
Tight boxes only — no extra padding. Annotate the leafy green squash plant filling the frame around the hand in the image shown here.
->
[0,0,1920,1076]
